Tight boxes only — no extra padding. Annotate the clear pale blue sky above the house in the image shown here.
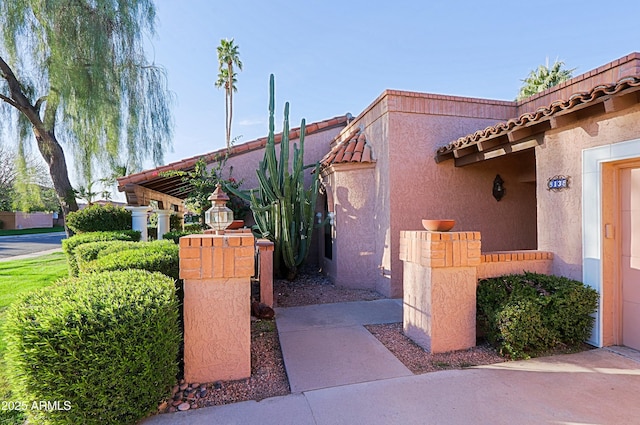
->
[154,0,640,163]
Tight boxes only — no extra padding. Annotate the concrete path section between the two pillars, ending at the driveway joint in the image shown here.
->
[276,300,412,393]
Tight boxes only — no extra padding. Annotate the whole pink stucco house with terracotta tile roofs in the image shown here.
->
[119,53,640,349]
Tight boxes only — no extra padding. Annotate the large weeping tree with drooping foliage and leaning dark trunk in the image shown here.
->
[0,0,171,232]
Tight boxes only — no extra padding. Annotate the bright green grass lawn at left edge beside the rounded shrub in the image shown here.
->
[0,252,68,425]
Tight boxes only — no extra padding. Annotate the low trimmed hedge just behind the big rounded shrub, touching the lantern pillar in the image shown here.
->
[83,241,180,279]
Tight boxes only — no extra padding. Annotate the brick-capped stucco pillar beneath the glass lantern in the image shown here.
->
[180,233,255,382]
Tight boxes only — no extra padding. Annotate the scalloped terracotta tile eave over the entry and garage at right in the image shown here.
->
[436,76,640,162]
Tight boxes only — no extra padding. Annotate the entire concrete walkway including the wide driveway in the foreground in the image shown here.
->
[143,300,640,425]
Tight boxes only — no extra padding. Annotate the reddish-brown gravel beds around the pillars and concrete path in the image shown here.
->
[158,269,505,413]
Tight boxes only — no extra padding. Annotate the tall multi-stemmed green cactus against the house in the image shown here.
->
[244,74,320,279]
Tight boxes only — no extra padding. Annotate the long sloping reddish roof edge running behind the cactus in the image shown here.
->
[118,114,353,187]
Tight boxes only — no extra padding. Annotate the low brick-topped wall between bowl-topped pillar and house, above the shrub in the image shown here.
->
[476,250,553,279]
